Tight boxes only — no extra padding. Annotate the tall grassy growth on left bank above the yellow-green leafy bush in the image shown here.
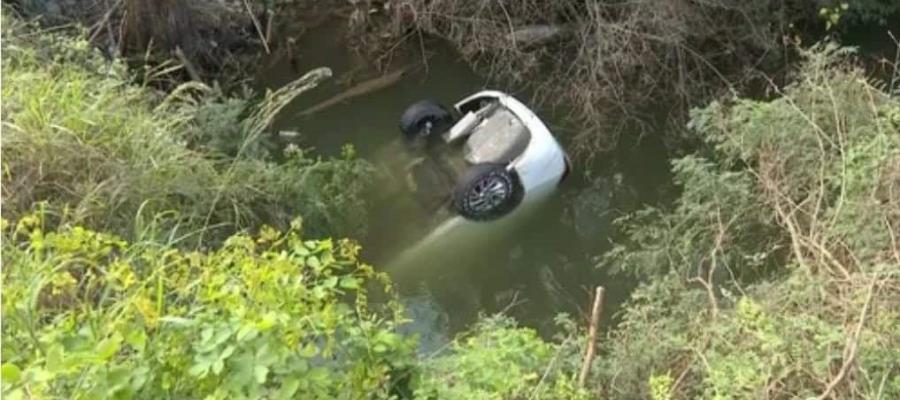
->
[2,18,370,243]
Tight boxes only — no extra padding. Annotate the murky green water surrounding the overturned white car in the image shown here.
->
[258,24,670,347]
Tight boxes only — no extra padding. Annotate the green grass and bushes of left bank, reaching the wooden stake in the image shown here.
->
[0,19,583,399]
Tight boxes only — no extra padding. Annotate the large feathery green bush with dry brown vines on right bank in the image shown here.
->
[596,45,900,399]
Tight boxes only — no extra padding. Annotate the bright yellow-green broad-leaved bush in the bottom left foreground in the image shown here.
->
[2,216,412,399]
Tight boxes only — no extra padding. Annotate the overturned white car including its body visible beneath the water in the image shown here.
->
[388,91,570,279]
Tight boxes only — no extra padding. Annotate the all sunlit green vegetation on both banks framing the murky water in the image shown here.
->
[0,5,900,400]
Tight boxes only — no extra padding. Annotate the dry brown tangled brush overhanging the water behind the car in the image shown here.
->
[392,0,790,155]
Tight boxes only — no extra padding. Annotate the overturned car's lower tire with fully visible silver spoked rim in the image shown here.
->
[453,163,525,221]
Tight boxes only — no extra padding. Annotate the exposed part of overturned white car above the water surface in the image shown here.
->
[400,91,570,222]
